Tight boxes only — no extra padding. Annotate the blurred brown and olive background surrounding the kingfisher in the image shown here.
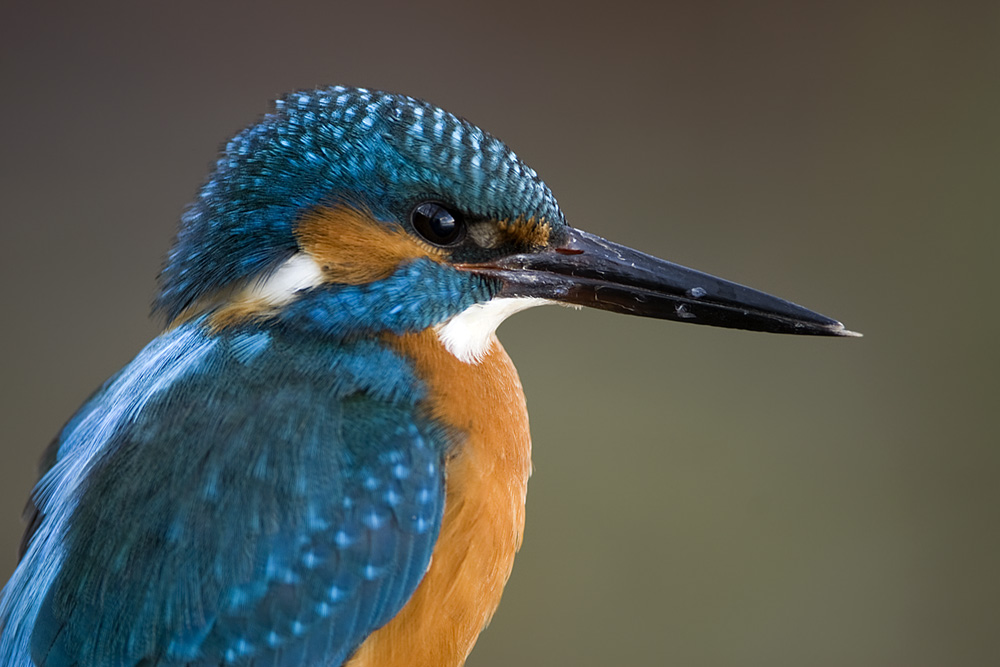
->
[0,0,1000,667]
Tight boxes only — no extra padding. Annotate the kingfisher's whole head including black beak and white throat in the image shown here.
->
[154,86,851,361]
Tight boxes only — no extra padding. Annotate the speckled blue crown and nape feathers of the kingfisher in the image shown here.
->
[154,86,565,319]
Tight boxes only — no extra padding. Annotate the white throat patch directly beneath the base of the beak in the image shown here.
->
[435,297,555,364]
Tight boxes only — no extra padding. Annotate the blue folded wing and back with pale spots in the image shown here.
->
[0,325,446,667]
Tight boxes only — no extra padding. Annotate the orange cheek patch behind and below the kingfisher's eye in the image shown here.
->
[295,207,445,285]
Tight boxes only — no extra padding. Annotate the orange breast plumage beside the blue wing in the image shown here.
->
[346,331,531,667]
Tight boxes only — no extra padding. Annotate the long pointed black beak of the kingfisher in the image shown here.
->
[462,228,860,336]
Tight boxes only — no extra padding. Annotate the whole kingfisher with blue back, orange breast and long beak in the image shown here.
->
[0,86,857,667]
